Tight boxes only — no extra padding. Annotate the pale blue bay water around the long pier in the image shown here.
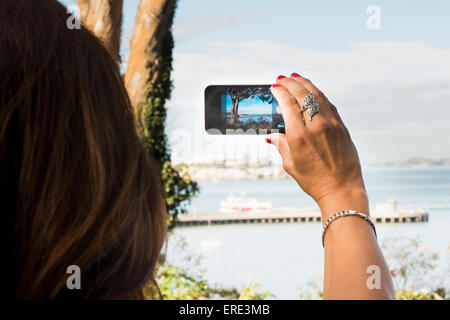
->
[169,168,450,299]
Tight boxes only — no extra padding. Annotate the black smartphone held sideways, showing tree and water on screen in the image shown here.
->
[205,85,284,134]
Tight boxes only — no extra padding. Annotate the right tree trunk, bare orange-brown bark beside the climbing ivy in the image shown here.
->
[125,0,176,108]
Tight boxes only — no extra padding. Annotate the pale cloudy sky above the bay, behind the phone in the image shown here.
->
[62,0,450,164]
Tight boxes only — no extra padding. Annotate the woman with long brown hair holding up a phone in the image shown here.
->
[0,0,393,299]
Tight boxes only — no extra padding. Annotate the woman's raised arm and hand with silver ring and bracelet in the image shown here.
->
[266,73,394,299]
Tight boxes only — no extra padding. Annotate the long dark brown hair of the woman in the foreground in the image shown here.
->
[0,0,167,299]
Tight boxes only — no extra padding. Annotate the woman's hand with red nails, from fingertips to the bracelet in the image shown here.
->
[266,73,369,219]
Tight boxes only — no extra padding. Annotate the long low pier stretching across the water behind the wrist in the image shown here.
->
[176,210,428,226]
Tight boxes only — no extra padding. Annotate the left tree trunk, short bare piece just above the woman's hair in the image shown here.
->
[78,0,123,60]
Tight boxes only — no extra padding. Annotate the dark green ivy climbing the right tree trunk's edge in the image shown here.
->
[136,24,199,229]
